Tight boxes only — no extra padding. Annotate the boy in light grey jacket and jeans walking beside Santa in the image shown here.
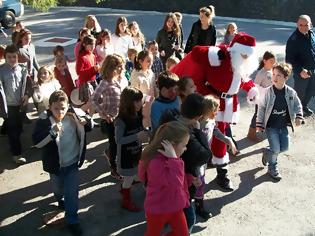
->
[256,63,303,180]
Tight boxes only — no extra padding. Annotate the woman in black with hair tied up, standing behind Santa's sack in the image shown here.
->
[184,5,217,54]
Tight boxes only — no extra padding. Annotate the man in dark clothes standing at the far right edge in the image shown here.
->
[286,15,315,116]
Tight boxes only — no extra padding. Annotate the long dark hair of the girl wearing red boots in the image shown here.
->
[118,86,143,122]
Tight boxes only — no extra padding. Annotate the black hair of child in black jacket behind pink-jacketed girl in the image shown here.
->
[181,93,205,119]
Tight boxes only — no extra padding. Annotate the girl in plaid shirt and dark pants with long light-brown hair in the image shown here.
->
[91,54,128,180]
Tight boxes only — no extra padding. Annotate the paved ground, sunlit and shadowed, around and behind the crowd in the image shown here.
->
[0,8,315,236]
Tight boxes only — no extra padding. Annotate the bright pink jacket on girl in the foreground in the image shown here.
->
[138,154,189,214]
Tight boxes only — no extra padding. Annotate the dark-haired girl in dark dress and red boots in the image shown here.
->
[115,87,149,212]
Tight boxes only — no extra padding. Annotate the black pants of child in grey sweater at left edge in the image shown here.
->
[5,106,23,156]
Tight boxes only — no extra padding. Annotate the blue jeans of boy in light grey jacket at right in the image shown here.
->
[266,127,289,170]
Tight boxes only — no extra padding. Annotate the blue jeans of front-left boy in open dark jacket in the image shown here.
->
[50,163,79,224]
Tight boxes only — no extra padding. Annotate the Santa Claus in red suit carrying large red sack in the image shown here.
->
[172,32,258,190]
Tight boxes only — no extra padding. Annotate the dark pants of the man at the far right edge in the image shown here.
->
[293,75,315,107]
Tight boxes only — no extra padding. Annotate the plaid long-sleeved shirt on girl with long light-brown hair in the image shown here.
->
[92,80,122,119]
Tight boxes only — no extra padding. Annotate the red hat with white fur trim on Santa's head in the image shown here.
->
[230,32,256,55]
